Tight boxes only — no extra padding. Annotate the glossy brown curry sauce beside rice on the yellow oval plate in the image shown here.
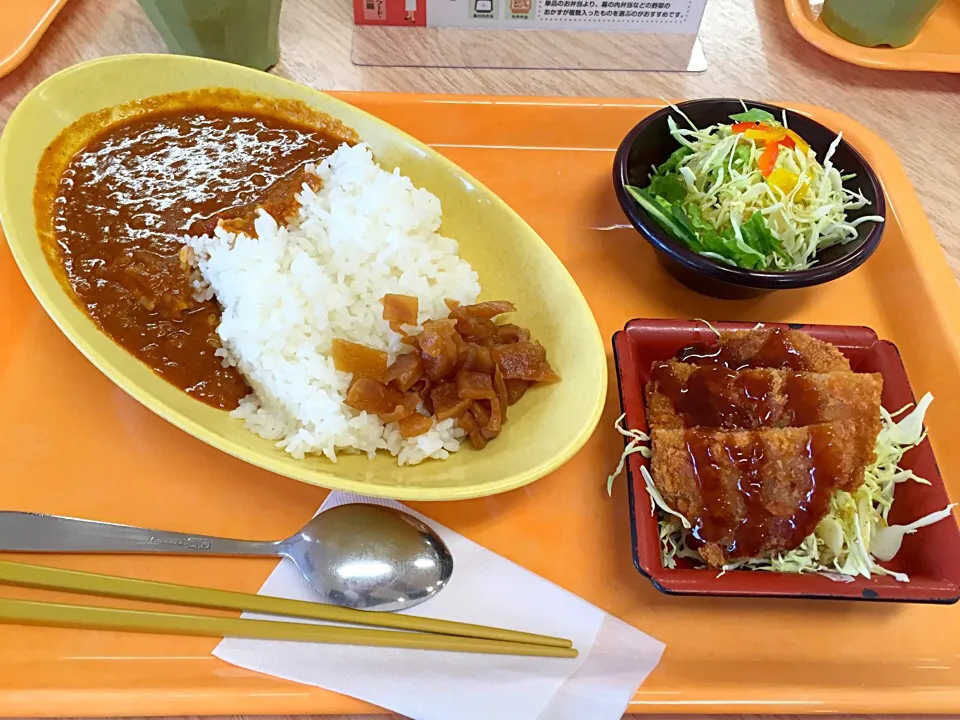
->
[44,102,343,409]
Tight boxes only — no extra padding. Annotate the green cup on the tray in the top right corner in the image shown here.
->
[820,0,941,47]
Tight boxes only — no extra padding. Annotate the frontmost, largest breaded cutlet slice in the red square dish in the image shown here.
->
[651,420,870,567]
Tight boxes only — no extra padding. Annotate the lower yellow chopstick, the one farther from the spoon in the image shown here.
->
[0,598,577,658]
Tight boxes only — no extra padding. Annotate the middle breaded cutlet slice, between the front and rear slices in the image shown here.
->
[644,360,883,440]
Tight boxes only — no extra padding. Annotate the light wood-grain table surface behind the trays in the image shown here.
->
[0,0,960,717]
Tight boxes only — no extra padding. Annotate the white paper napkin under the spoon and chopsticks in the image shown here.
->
[213,492,664,720]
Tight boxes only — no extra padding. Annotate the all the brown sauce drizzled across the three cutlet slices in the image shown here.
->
[664,329,844,558]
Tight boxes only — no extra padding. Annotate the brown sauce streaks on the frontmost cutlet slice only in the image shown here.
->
[685,425,843,558]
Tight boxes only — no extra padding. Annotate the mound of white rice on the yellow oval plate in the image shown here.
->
[184,145,480,465]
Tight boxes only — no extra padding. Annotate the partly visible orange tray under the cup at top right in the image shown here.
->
[784,0,960,73]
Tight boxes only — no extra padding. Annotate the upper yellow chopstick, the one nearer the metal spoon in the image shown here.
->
[0,560,573,648]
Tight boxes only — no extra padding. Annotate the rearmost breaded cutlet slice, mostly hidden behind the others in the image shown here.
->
[678,328,850,373]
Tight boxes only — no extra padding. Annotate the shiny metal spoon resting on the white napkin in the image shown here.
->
[0,503,453,611]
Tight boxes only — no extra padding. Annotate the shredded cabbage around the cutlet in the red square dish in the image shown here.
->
[608,393,957,582]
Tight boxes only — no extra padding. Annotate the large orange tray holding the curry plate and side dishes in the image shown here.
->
[0,93,960,716]
